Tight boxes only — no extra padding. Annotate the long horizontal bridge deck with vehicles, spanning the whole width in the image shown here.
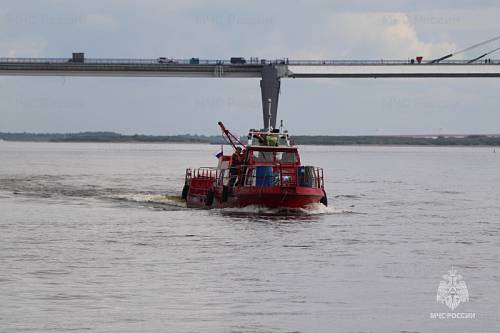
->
[0,58,500,78]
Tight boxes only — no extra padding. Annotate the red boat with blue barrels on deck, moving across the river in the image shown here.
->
[182,122,328,208]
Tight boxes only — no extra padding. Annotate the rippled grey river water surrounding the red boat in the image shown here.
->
[0,142,500,332]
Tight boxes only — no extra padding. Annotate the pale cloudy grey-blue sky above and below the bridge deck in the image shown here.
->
[0,0,500,135]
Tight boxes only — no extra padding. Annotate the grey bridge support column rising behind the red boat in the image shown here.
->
[260,65,281,129]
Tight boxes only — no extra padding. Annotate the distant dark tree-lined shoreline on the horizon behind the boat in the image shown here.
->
[0,132,500,147]
